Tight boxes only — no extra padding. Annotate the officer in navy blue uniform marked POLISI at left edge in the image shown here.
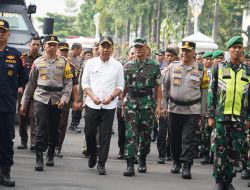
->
[0,19,29,187]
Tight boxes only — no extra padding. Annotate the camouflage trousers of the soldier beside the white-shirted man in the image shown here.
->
[125,108,155,158]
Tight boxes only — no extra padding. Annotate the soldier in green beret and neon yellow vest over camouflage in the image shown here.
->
[208,36,250,190]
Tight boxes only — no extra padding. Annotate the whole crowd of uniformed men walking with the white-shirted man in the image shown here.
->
[0,20,250,190]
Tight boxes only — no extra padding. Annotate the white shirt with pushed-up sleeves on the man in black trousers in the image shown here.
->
[82,57,124,109]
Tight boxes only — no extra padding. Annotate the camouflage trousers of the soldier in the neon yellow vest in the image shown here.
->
[211,121,245,180]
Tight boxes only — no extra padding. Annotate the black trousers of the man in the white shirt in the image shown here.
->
[84,106,115,164]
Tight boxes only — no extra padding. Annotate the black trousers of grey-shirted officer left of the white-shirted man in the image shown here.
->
[35,101,61,154]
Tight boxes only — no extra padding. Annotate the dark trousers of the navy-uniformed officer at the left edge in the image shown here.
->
[0,112,15,167]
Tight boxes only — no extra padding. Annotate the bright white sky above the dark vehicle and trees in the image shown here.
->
[25,0,83,34]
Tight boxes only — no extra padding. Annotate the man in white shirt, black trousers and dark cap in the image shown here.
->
[82,36,124,175]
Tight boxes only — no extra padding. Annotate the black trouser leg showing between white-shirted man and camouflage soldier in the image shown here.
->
[116,108,126,152]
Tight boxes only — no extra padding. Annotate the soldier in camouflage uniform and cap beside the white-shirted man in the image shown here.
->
[123,38,162,176]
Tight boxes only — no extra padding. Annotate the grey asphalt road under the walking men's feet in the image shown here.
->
[0,116,250,190]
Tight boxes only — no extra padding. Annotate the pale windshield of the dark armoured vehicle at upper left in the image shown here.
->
[0,12,28,31]
